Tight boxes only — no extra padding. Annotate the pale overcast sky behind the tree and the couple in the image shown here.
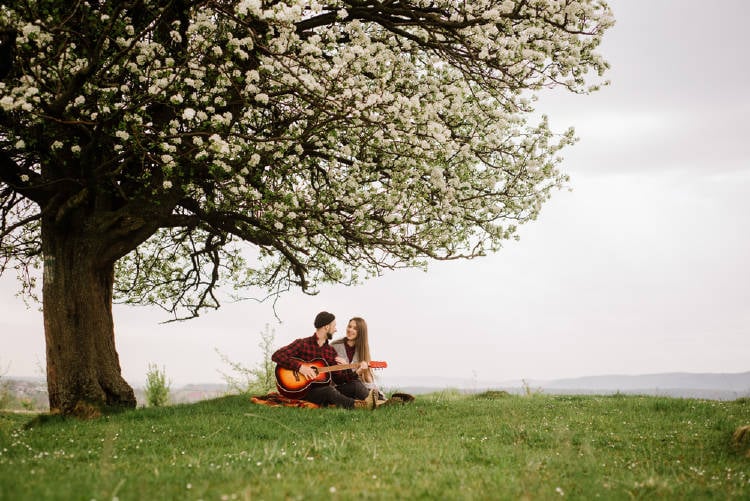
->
[0,0,750,388]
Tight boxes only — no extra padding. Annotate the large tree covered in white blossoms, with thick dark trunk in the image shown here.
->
[0,0,612,414]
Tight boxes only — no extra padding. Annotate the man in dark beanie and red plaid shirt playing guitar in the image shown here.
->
[271,311,378,409]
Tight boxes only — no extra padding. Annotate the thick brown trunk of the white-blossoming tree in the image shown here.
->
[42,219,136,417]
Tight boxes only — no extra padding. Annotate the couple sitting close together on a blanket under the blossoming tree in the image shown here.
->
[271,311,396,410]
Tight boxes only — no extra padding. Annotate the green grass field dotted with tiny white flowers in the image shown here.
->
[0,391,750,500]
